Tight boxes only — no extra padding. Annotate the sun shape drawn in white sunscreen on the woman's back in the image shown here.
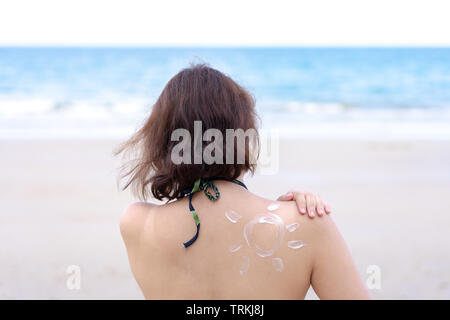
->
[225,203,305,276]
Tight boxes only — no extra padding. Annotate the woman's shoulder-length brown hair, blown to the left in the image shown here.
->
[115,64,259,200]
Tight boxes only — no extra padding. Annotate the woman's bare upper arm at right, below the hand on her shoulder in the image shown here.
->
[311,217,371,299]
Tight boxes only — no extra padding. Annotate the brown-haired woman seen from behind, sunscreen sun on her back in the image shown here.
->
[117,65,370,299]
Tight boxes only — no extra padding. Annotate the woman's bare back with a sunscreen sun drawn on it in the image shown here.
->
[121,181,370,299]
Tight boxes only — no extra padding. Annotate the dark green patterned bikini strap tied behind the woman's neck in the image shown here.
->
[180,177,247,248]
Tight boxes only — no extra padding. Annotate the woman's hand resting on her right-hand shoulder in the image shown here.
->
[277,190,331,218]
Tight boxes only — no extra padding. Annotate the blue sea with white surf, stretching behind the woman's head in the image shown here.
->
[0,47,450,140]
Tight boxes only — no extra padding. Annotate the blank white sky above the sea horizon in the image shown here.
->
[0,0,450,46]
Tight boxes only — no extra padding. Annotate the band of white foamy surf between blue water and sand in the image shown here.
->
[0,97,450,140]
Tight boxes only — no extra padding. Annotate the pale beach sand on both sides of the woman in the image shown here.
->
[0,140,450,299]
